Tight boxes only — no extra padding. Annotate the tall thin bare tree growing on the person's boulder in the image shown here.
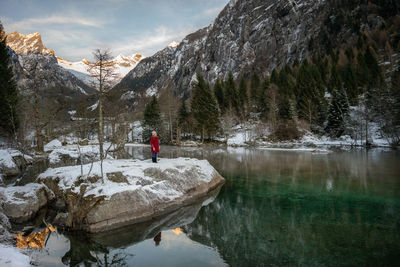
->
[87,49,118,177]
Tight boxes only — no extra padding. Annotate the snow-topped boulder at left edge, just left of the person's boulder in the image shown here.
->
[0,183,54,222]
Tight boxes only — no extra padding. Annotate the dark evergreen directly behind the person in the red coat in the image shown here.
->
[143,95,163,142]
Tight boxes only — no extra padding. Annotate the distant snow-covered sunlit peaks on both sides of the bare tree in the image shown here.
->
[56,54,144,85]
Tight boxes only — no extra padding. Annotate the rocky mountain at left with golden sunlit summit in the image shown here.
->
[6,32,95,96]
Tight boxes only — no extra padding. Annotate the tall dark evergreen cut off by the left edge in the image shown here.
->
[0,23,19,135]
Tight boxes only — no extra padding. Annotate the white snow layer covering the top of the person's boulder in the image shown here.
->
[39,158,215,200]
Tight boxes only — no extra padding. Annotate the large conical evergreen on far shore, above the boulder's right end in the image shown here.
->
[191,75,219,141]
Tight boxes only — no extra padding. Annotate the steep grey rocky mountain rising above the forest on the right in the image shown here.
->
[115,0,400,107]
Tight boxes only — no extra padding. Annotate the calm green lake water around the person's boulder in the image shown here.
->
[30,147,400,266]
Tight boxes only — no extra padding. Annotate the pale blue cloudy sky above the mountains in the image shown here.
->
[0,0,229,61]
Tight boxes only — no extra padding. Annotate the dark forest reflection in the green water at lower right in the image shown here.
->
[184,185,400,266]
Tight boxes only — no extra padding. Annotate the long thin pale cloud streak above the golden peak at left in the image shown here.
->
[7,15,105,31]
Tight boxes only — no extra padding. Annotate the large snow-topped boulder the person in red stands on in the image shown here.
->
[38,158,225,232]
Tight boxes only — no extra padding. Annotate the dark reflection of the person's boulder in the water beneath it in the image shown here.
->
[62,188,219,266]
